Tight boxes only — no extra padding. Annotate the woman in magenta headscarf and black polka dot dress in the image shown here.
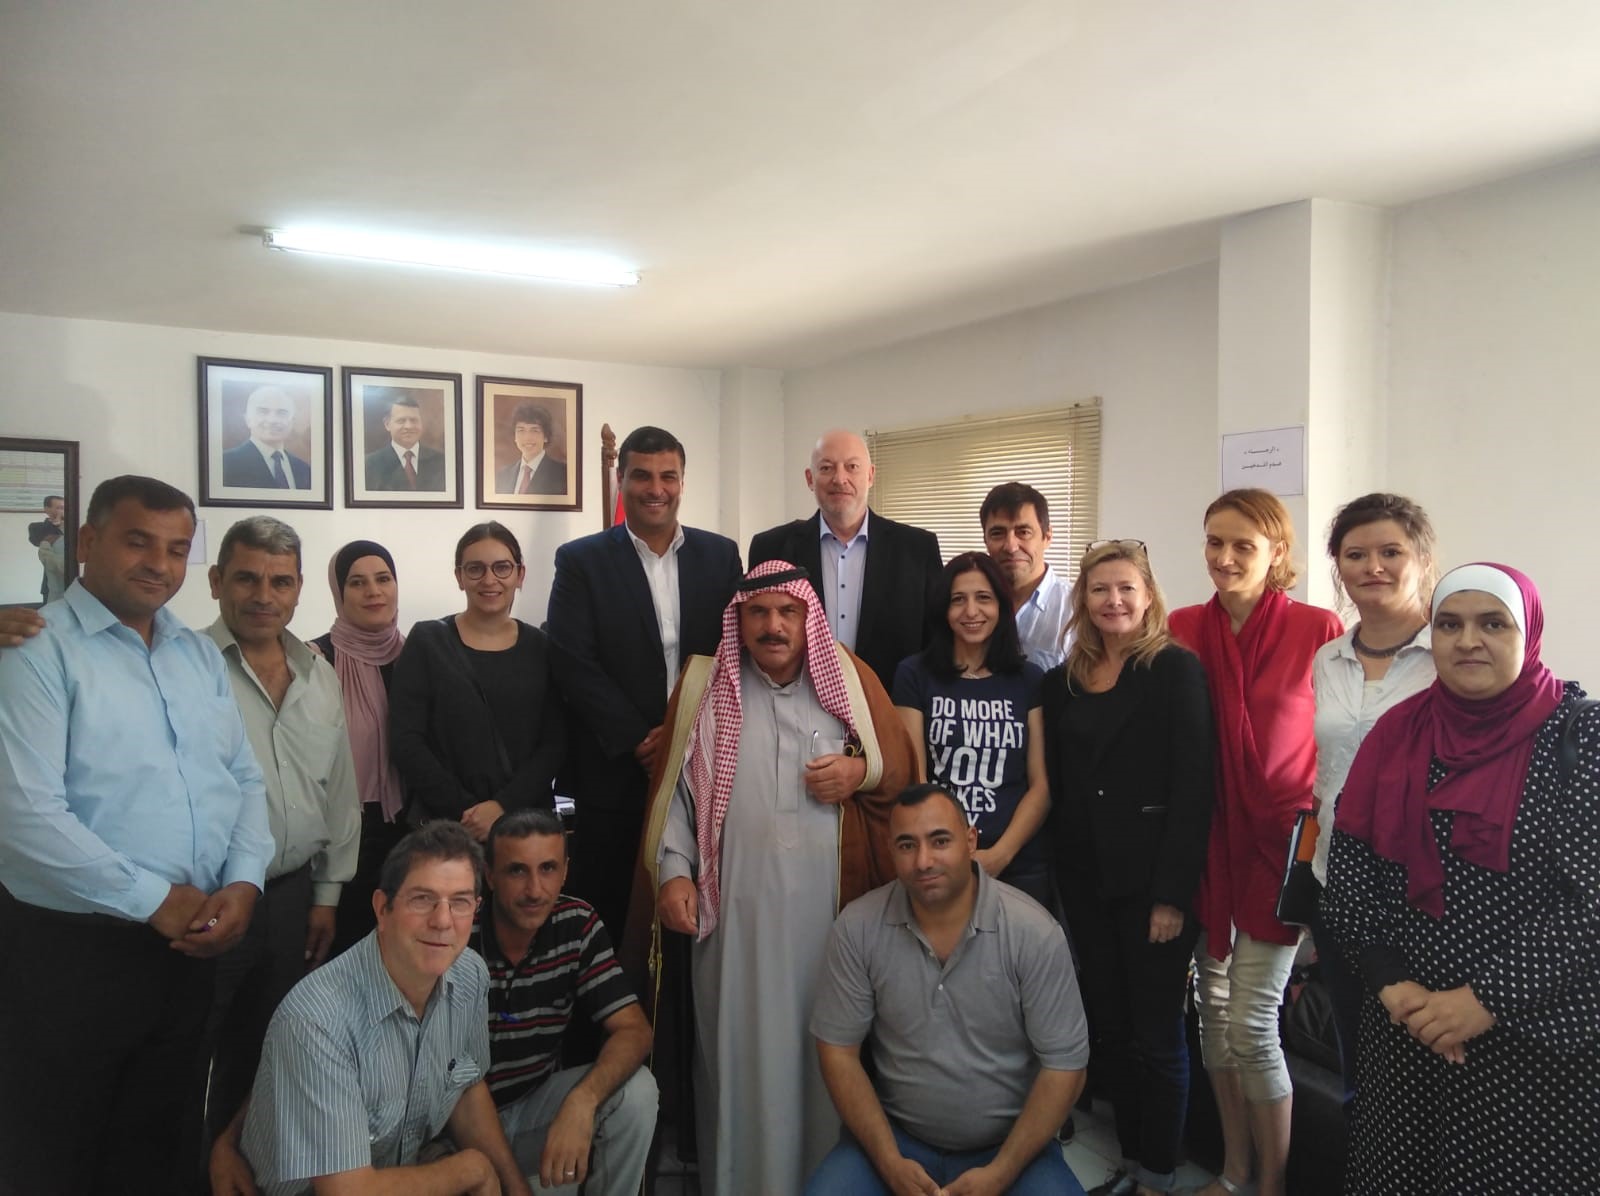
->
[1323,564,1600,1196]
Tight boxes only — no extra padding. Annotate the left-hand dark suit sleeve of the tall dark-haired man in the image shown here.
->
[549,537,652,756]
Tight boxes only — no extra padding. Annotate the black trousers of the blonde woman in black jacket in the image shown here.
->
[1067,895,1200,1175]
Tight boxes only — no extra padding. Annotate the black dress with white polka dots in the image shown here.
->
[1323,683,1600,1196]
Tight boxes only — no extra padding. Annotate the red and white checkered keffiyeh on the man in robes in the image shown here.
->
[683,561,856,939]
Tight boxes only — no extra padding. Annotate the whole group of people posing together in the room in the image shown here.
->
[0,427,1600,1196]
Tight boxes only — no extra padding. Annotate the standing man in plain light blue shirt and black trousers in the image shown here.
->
[0,476,274,1191]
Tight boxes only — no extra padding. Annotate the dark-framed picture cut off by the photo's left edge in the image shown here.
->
[0,437,83,606]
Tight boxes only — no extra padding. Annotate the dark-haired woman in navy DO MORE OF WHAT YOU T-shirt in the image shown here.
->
[894,552,1054,910]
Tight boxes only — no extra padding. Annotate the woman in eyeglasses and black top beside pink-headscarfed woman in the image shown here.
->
[389,521,565,843]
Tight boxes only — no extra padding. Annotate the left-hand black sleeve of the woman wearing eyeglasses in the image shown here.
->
[389,619,482,819]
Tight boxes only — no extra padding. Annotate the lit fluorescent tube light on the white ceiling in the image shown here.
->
[261,229,638,286]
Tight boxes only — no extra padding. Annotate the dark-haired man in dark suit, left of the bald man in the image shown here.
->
[547,427,732,942]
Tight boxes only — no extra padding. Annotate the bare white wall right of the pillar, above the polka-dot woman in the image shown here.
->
[1389,158,1600,689]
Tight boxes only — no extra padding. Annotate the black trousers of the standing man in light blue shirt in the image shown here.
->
[0,891,213,1196]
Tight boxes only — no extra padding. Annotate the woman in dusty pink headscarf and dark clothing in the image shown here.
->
[312,540,406,953]
